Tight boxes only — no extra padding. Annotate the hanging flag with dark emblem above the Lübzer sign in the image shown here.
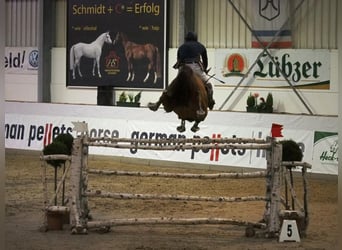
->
[252,0,292,48]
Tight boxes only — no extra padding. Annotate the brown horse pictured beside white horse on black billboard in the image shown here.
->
[113,32,161,83]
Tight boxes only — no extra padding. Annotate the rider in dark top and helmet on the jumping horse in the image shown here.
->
[174,31,215,110]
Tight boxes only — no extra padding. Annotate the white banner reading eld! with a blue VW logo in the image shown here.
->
[5,47,38,75]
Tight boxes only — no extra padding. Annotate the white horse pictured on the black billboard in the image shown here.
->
[70,32,112,79]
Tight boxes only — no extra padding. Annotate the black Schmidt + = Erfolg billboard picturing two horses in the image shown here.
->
[67,0,166,89]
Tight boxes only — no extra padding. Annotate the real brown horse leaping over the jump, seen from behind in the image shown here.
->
[148,65,208,132]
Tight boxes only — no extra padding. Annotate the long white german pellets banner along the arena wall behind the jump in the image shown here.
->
[5,103,338,175]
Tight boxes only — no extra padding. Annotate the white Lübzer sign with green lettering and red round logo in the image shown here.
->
[215,49,330,90]
